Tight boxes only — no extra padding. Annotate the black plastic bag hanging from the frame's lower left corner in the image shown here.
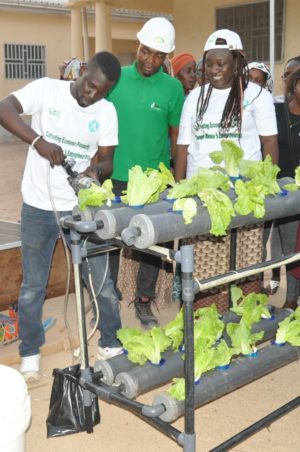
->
[46,364,100,438]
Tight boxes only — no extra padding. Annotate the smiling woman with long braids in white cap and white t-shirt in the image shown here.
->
[175,29,278,181]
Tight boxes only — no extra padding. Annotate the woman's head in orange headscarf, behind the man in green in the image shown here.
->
[171,52,196,96]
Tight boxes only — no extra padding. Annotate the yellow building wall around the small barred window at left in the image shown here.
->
[0,9,142,99]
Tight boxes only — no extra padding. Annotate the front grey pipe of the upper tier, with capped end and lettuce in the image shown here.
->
[122,177,300,249]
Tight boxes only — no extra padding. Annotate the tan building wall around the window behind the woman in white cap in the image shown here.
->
[173,0,300,95]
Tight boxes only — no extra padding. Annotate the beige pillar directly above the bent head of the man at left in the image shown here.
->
[95,0,112,52]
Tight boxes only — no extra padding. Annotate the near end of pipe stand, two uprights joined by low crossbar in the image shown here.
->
[60,217,195,452]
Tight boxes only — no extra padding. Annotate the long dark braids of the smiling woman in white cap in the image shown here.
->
[194,50,249,136]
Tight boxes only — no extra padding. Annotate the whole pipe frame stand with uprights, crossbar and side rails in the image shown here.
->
[61,217,300,452]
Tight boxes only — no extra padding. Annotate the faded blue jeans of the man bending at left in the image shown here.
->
[19,203,121,356]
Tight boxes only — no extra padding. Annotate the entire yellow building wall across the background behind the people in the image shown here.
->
[0,0,300,98]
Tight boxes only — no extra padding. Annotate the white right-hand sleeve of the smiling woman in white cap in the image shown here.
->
[253,89,277,136]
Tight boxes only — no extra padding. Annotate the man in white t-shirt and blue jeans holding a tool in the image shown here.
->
[0,52,122,380]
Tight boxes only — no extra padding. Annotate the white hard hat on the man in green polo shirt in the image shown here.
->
[136,17,175,53]
